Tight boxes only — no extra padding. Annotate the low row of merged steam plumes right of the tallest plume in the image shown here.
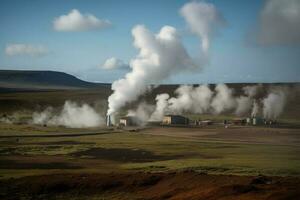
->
[145,84,287,121]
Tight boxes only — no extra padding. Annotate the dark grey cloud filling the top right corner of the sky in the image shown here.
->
[257,0,300,45]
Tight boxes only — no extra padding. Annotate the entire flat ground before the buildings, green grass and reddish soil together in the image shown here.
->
[0,123,300,199]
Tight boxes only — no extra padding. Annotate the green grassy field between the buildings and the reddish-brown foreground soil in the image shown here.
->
[0,124,300,178]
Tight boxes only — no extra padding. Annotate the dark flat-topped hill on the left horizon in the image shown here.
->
[0,70,107,89]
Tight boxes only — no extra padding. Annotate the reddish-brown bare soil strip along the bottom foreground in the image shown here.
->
[0,171,300,200]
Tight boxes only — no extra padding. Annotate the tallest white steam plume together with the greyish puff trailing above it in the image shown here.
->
[107,2,220,122]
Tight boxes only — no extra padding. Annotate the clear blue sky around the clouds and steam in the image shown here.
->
[0,0,300,83]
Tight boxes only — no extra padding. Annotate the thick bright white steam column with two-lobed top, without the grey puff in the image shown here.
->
[107,25,196,120]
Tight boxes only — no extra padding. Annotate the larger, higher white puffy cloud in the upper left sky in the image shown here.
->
[53,9,111,31]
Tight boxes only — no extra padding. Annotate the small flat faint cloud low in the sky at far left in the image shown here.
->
[5,44,48,56]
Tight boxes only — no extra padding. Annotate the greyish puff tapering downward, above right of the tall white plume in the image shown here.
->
[179,1,225,53]
